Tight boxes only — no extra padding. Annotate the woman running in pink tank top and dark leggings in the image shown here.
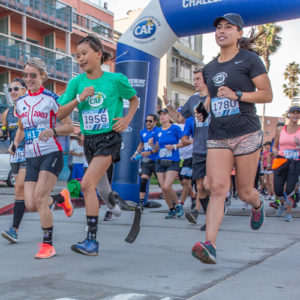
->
[272,106,300,222]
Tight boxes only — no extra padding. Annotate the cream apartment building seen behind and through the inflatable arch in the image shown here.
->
[114,9,203,107]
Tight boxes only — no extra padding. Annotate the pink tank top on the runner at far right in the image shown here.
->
[278,126,300,159]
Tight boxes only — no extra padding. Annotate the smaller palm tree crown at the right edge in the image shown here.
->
[282,61,300,106]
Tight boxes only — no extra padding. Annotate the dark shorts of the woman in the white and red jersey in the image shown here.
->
[25,151,64,182]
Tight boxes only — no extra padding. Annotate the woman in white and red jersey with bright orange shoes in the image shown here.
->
[11,57,73,258]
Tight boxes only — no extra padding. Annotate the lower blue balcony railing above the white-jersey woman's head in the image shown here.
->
[0,34,72,82]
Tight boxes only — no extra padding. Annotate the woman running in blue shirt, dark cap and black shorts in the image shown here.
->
[149,108,184,219]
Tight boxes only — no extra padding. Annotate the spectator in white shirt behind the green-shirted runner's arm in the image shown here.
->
[69,132,85,179]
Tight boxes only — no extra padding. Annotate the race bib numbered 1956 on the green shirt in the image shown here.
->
[82,108,109,130]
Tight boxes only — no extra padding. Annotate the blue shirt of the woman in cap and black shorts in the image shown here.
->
[157,124,182,161]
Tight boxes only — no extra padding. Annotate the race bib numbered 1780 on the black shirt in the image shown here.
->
[211,97,240,118]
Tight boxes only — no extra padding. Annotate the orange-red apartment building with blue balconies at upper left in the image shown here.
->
[0,0,116,109]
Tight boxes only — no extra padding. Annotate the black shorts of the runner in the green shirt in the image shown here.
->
[84,131,122,164]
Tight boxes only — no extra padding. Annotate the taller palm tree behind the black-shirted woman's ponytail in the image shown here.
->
[255,23,282,130]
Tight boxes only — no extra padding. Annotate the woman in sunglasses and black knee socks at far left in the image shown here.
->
[1,78,27,243]
